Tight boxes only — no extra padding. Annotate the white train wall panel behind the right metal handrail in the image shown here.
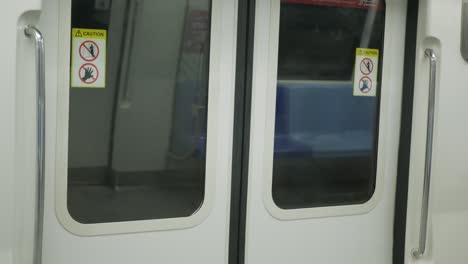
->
[406,0,468,264]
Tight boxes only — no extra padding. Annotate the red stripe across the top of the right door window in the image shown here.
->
[281,0,383,9]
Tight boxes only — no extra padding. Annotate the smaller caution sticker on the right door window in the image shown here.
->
[353,48,379,96]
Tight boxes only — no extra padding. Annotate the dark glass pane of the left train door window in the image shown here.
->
[68,0,211,223]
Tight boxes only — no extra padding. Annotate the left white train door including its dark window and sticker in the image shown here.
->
[16,0,237,264]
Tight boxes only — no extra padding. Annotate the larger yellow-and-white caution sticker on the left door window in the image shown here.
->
[70,28,107,88]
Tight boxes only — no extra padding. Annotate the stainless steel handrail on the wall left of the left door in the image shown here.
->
[24,26,45,264]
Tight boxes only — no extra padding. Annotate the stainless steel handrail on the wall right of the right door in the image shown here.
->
[412,49,437,258]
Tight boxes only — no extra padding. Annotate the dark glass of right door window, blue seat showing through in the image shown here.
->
[272,0,385,209]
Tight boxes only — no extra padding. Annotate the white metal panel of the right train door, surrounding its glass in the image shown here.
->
[246,0,406,264]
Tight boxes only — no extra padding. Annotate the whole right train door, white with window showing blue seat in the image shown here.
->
[245,0,406,264]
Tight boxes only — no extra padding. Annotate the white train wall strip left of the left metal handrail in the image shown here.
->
[5,1,42,263]
